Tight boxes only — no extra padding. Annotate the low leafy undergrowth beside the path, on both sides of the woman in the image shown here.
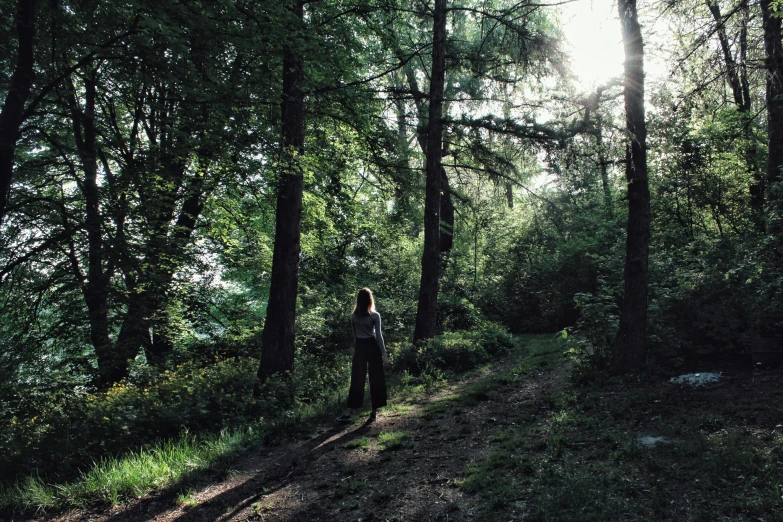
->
[0,305,514,500]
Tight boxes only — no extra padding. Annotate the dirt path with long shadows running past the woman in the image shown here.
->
[47,362,563,522]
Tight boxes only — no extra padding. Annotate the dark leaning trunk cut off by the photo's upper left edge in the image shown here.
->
[0,0,35,222]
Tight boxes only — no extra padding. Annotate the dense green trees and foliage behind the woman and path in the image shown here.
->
[0,0,783,519]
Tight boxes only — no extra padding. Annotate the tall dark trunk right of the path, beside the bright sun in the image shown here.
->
[612,0,650,373]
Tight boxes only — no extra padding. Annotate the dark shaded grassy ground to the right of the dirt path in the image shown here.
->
[459,340,783,522]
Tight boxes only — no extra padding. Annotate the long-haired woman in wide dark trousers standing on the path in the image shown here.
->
[337,288,389,423]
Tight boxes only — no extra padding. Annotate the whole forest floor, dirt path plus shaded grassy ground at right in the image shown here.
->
[30,336,783,522]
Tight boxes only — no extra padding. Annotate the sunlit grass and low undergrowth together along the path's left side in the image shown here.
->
[0,324,514,513]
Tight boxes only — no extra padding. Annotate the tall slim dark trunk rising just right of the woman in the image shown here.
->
[413,0,446,341]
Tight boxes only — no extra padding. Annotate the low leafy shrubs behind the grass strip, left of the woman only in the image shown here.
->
[0,352,349,482]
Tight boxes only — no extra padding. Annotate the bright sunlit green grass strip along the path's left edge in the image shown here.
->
[0,328,532,513]
